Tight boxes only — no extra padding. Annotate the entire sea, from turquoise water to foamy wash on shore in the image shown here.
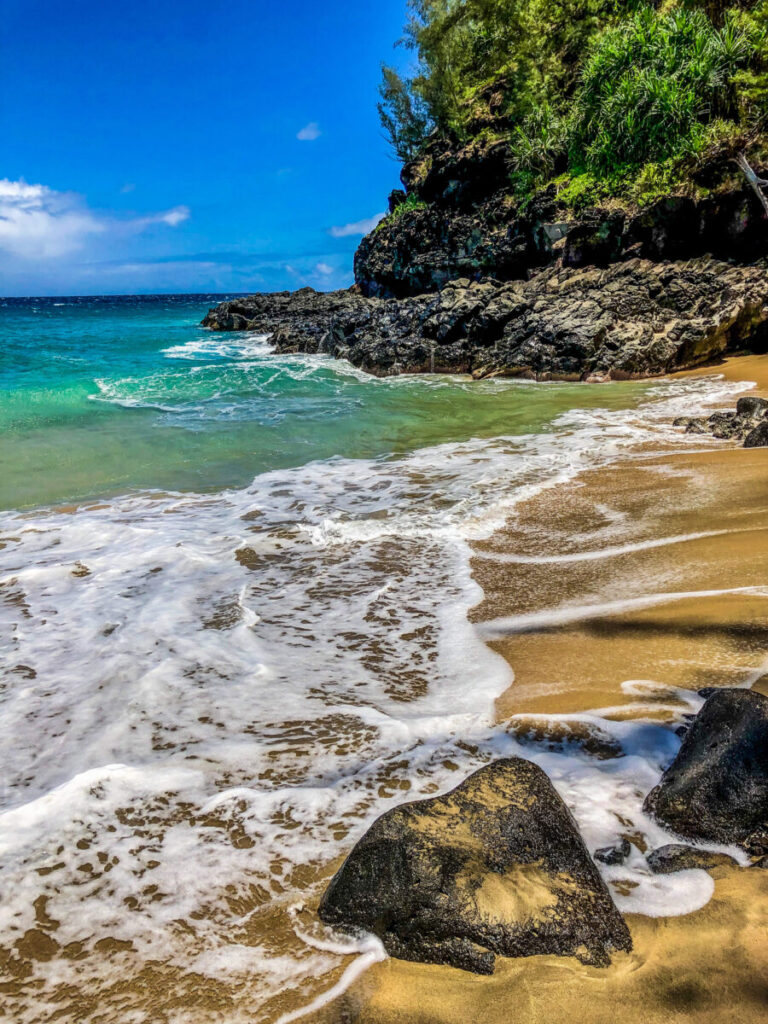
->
[0,295,739,1024]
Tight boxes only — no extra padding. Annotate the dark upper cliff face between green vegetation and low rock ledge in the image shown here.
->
[354,138,768,298]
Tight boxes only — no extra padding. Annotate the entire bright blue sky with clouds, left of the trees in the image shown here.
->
[0,0,407,295]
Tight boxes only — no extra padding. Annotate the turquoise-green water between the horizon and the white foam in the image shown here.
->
[0,296,663,508]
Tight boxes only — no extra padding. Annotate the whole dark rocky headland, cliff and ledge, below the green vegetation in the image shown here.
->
[203,134,768,380]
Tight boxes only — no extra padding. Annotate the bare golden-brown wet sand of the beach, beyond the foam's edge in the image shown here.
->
[339,356,768,1024]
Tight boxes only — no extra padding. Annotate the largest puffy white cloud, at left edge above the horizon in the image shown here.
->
[0,178,189,259]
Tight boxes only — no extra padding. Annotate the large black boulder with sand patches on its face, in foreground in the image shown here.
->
[319,758,632,974]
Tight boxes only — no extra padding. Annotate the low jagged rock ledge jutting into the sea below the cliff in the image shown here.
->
[204,259,768,380]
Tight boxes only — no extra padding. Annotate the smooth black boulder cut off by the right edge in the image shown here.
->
[644,689,768,852]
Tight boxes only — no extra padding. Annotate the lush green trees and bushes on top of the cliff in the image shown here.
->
[379,0,768,200]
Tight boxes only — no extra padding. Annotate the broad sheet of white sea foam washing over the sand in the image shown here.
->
[0,362,757,1024]
